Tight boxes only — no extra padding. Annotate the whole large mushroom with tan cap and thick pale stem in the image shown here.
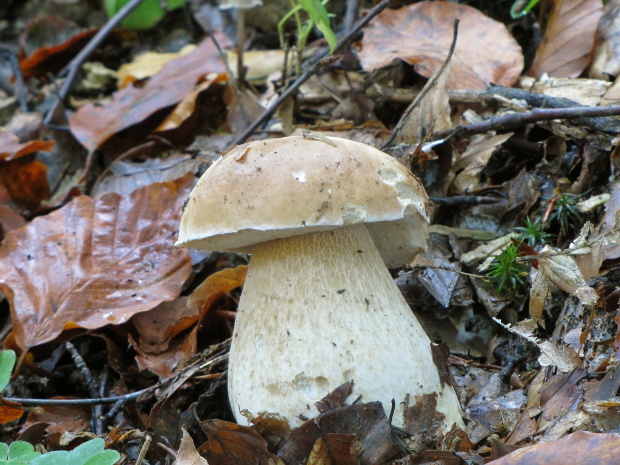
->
[177,133,462,430]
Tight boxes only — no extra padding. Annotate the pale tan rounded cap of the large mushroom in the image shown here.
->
[176,136,430,266]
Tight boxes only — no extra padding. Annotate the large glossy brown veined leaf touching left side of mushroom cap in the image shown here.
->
[0,174,194,348]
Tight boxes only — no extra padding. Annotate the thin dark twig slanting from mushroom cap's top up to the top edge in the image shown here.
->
[232,0,394,145]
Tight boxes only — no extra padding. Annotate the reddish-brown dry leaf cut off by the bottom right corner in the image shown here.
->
[488,431,620,465]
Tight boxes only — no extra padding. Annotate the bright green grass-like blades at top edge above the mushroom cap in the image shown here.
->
[278,0,338,74]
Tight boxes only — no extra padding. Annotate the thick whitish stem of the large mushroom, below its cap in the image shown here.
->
[228,224,462,431]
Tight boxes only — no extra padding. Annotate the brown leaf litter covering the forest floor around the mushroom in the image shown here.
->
[0,0,620,465]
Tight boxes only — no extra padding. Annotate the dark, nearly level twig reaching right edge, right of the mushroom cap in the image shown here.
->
[433,105,620,139]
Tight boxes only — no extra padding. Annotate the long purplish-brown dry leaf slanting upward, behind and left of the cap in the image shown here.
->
[70,32,230,150]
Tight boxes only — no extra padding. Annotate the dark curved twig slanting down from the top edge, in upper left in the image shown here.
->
[43,0,144,126]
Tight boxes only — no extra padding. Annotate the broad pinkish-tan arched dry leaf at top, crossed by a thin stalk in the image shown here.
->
[359,1,523,89]
